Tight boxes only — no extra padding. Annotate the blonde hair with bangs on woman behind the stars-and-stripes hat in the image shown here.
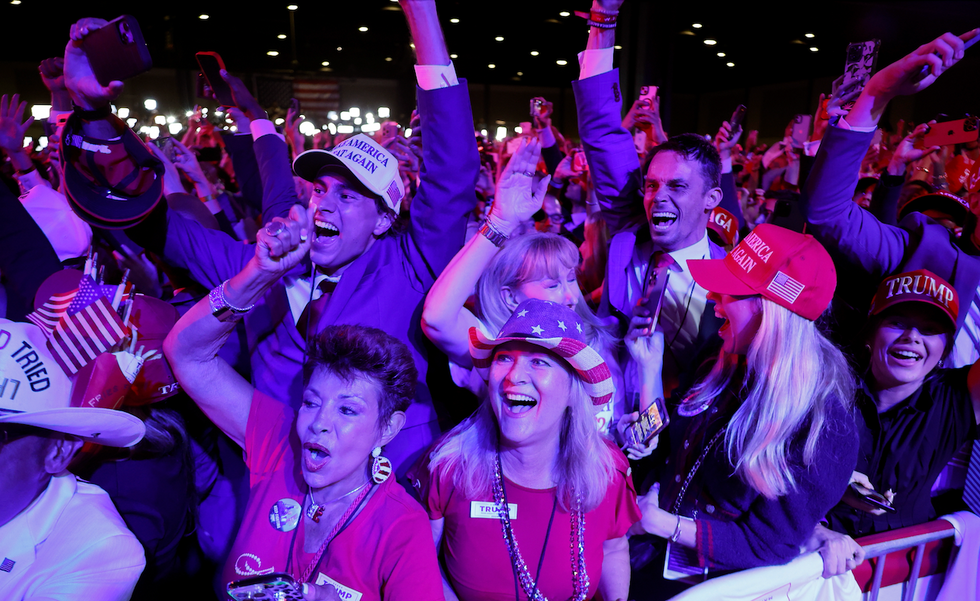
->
[476,232,615,349]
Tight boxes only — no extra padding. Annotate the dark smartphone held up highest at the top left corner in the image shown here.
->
[82,15,153,86]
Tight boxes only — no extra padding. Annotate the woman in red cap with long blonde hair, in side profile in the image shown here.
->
[627,224,857,599]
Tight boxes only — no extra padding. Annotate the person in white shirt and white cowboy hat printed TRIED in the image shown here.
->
[0,319,146,601]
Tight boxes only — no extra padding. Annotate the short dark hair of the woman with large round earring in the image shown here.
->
[303,325,418,430]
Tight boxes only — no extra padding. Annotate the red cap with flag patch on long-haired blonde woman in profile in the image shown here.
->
[687,223,837,321]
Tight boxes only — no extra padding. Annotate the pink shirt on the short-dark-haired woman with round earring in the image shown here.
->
[222,391,443,601]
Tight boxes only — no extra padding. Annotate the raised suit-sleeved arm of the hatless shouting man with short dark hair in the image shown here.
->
[572,0,644,234]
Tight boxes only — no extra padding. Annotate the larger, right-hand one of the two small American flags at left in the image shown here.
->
[48,276,126,375]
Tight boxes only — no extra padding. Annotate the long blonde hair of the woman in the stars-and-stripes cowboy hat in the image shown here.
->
[429,374,615,512]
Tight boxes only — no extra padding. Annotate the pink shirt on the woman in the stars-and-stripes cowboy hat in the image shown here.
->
[417,447,640,601]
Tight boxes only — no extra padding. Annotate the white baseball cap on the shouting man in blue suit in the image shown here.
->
[293,134,405,213]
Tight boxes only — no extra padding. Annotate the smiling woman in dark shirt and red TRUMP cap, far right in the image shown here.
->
[817,269,980,571]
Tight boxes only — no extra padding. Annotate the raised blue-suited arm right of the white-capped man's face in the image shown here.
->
[401,0,480,276]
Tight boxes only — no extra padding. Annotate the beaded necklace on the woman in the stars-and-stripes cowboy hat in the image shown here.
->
[493,451,589,601]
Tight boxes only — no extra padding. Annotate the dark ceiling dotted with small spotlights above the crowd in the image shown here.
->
[0,0,980,93]
